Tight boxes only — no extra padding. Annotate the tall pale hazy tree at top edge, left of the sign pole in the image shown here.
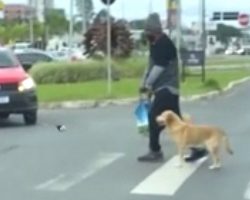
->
[76,0,94,29]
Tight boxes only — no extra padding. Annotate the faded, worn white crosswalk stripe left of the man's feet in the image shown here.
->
[35,153,124,192]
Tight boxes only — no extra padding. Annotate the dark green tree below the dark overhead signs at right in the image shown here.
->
[215,24,242,45]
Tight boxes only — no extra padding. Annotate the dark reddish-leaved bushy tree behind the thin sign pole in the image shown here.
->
[84,10,133,57]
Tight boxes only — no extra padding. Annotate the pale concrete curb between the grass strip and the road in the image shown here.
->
[39,76,250,109]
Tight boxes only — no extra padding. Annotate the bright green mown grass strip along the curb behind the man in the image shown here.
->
[38,69,250,102]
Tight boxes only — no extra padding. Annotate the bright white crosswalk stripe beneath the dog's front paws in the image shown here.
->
[131,156,207,196]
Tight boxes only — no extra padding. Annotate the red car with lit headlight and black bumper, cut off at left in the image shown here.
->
[0,47,38,125]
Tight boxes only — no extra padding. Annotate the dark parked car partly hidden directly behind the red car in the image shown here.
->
[15,48,55,71]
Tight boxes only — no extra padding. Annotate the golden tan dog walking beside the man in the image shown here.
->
[156,110,233,169]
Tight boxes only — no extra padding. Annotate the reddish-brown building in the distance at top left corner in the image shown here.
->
[4,4,32,21]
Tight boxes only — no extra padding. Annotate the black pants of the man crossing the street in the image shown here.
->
[149,88,181,152]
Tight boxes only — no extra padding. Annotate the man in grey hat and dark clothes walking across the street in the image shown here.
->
[138,13,206,162]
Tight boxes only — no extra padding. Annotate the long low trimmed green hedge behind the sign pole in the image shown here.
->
[29,58,147,84]
